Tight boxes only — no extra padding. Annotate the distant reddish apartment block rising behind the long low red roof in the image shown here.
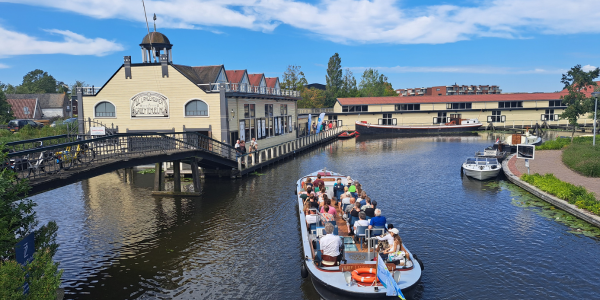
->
[396,84,502,96]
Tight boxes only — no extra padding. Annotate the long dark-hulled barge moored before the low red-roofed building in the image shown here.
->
[355,114,483,135]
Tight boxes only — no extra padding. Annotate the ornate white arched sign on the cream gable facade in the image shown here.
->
[130,92,169,118]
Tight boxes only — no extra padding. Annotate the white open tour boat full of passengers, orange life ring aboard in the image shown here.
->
[296,169,424,299]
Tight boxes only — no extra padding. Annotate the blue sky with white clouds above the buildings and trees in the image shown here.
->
[0,0,600,92]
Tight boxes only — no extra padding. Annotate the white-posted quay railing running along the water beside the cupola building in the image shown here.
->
[237,127,347,171]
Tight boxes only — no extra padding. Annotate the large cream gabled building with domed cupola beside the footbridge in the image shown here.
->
[78,32,300,148]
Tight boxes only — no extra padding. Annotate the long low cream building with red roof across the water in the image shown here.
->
[327,91,593,127]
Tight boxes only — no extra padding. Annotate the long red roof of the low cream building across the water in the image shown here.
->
[337,92,567,105]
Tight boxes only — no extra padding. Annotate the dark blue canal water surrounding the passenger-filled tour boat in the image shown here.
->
[32,134,600,300]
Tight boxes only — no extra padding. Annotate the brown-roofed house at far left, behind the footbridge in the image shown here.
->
[6,94,71,119]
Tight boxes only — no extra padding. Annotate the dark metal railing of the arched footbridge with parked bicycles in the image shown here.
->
[0,132,236,179]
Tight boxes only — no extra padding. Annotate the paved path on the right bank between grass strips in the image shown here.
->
[508,150,600,199]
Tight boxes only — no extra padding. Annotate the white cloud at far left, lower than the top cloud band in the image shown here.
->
[0,27,124,56]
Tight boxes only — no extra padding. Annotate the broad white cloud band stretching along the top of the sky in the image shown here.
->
[0,0,600,44]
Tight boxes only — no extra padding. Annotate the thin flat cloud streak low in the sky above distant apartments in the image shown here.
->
[350,66,567,74]
